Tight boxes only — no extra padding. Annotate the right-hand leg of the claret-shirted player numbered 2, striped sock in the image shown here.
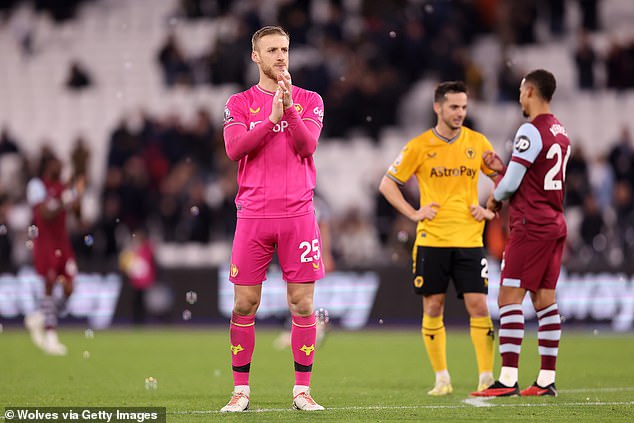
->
[522,239,565,396]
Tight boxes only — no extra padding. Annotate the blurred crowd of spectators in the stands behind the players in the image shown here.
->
[0,0,634,270]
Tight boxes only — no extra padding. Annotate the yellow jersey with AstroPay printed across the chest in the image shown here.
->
[387,126,495,247]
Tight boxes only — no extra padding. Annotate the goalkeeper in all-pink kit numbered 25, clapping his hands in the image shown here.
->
[220,26,324,412]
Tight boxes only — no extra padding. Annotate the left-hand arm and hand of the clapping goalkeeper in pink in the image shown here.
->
[223,93,282,161]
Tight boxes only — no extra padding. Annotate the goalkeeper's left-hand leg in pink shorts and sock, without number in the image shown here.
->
[220,219,274,412]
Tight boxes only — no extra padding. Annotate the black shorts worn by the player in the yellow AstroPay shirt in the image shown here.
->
[412,246,489,299]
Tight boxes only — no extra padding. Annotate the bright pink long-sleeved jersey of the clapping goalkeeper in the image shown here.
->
[223,85,324,218]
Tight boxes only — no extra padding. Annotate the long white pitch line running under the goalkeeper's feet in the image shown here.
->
[167,399,634,414]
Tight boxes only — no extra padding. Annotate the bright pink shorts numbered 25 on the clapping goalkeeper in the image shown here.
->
[229,212,324,285]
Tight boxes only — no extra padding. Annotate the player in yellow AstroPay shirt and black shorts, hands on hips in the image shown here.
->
[379,81,497,395]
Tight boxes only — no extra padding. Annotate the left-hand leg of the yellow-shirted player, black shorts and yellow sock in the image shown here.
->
[412,246,453,395]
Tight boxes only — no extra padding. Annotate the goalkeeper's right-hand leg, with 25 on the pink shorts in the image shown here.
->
[272,213,324,411]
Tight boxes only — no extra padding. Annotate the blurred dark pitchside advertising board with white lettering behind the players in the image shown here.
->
[0,260,634,331]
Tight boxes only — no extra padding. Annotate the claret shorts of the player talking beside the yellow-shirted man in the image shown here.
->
[501,232,566,292]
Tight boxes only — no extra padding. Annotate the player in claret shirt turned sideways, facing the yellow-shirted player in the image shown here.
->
[471,69,570,397]
